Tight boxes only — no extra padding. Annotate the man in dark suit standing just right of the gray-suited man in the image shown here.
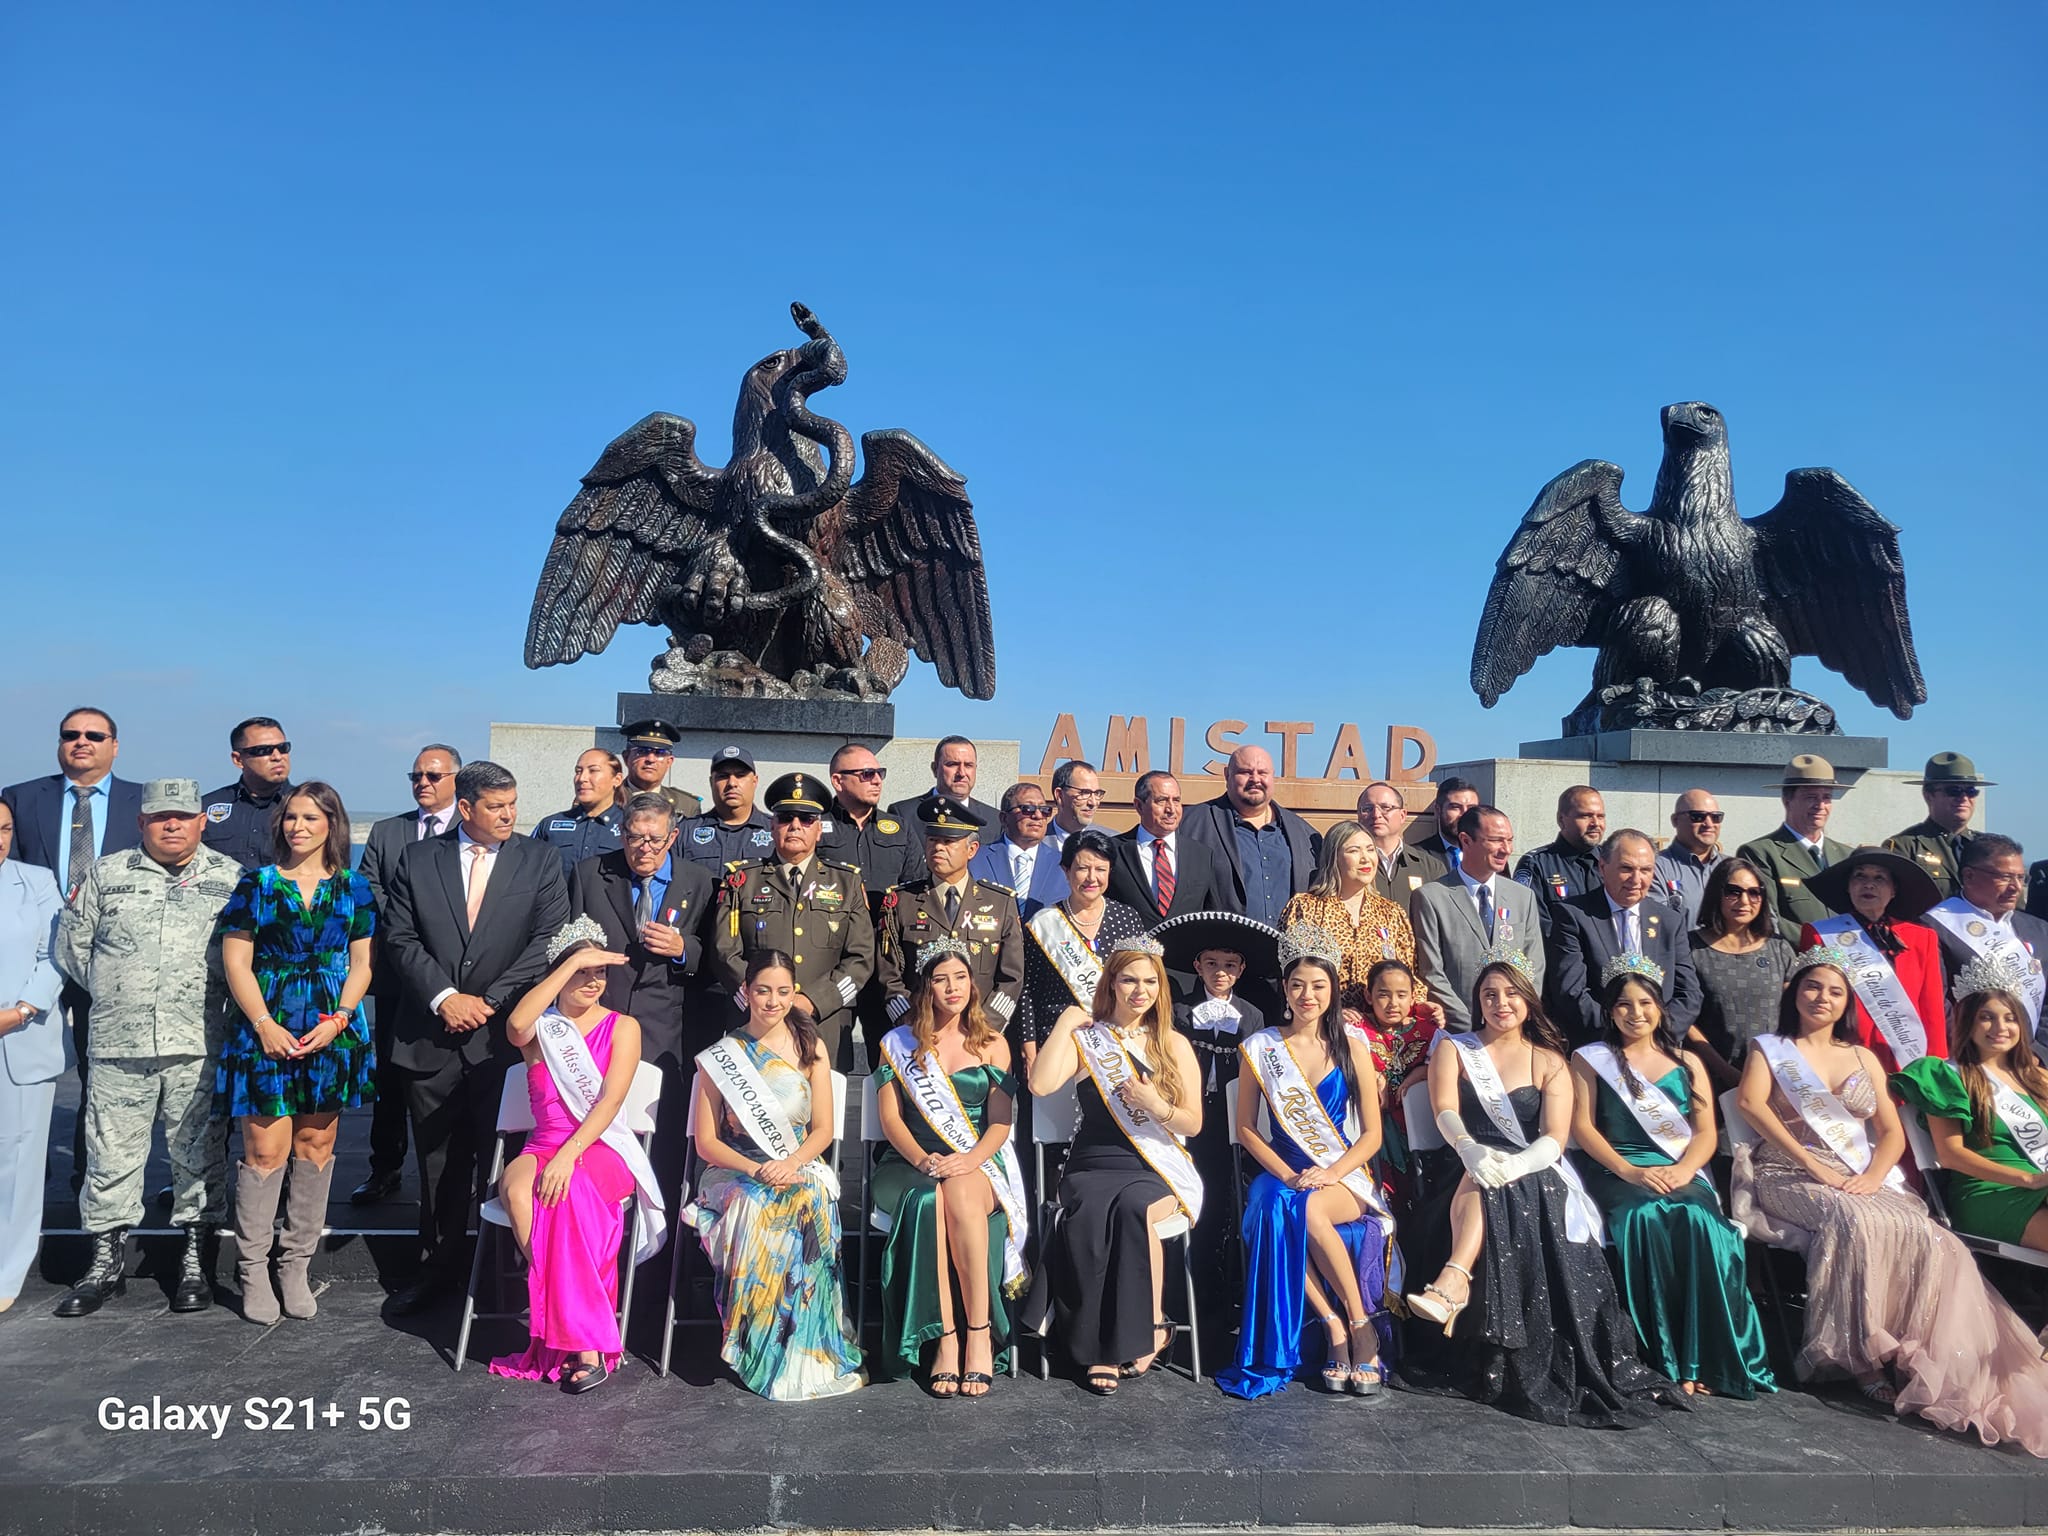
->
[1544,827,1702,1044]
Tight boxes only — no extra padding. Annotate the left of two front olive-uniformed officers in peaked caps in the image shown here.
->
[717,774,874,1071]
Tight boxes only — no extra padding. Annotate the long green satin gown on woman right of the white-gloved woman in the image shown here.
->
[1573,1069,1778,1399]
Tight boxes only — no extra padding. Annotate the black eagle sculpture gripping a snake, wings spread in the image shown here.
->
[526,303,995,698]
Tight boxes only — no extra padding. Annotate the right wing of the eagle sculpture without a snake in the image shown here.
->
[1745,469,1927,719]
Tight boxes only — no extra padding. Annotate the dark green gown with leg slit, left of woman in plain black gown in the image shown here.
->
[868,1061,1016,1376]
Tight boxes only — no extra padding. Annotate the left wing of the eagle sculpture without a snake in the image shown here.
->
[1473,459,1636,709]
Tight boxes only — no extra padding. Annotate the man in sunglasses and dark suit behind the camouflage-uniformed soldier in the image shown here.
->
[0,707,141,1190]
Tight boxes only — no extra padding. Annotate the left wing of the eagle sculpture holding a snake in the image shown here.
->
[526,412,721,668]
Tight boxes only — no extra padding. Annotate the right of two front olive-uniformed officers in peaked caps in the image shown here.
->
[868,795,1024,1057]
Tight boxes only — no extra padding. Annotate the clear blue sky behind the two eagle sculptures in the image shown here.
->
[0,4,2048,854]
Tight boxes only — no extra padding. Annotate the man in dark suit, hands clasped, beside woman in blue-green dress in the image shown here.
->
[381,762,569,1317]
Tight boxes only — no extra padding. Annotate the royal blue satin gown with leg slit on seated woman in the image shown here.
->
[1217,1067,1395,1397]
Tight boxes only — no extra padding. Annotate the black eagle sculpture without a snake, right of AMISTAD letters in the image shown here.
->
[1473,401,1927,733]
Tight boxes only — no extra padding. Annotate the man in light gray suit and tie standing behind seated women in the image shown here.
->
[1409,805,1544,1030]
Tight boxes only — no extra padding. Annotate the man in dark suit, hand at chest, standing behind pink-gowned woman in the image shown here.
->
[569,795,731,1190]
